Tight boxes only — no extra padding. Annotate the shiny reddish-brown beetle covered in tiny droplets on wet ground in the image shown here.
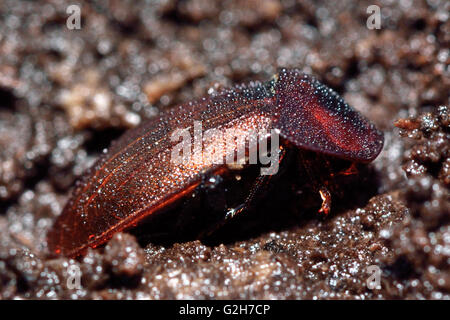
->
[47,68,384,257]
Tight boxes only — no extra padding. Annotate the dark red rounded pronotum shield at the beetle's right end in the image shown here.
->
[274,69,384,162]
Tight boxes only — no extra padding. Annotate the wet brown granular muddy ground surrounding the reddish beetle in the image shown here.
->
[0,0,450,299]
